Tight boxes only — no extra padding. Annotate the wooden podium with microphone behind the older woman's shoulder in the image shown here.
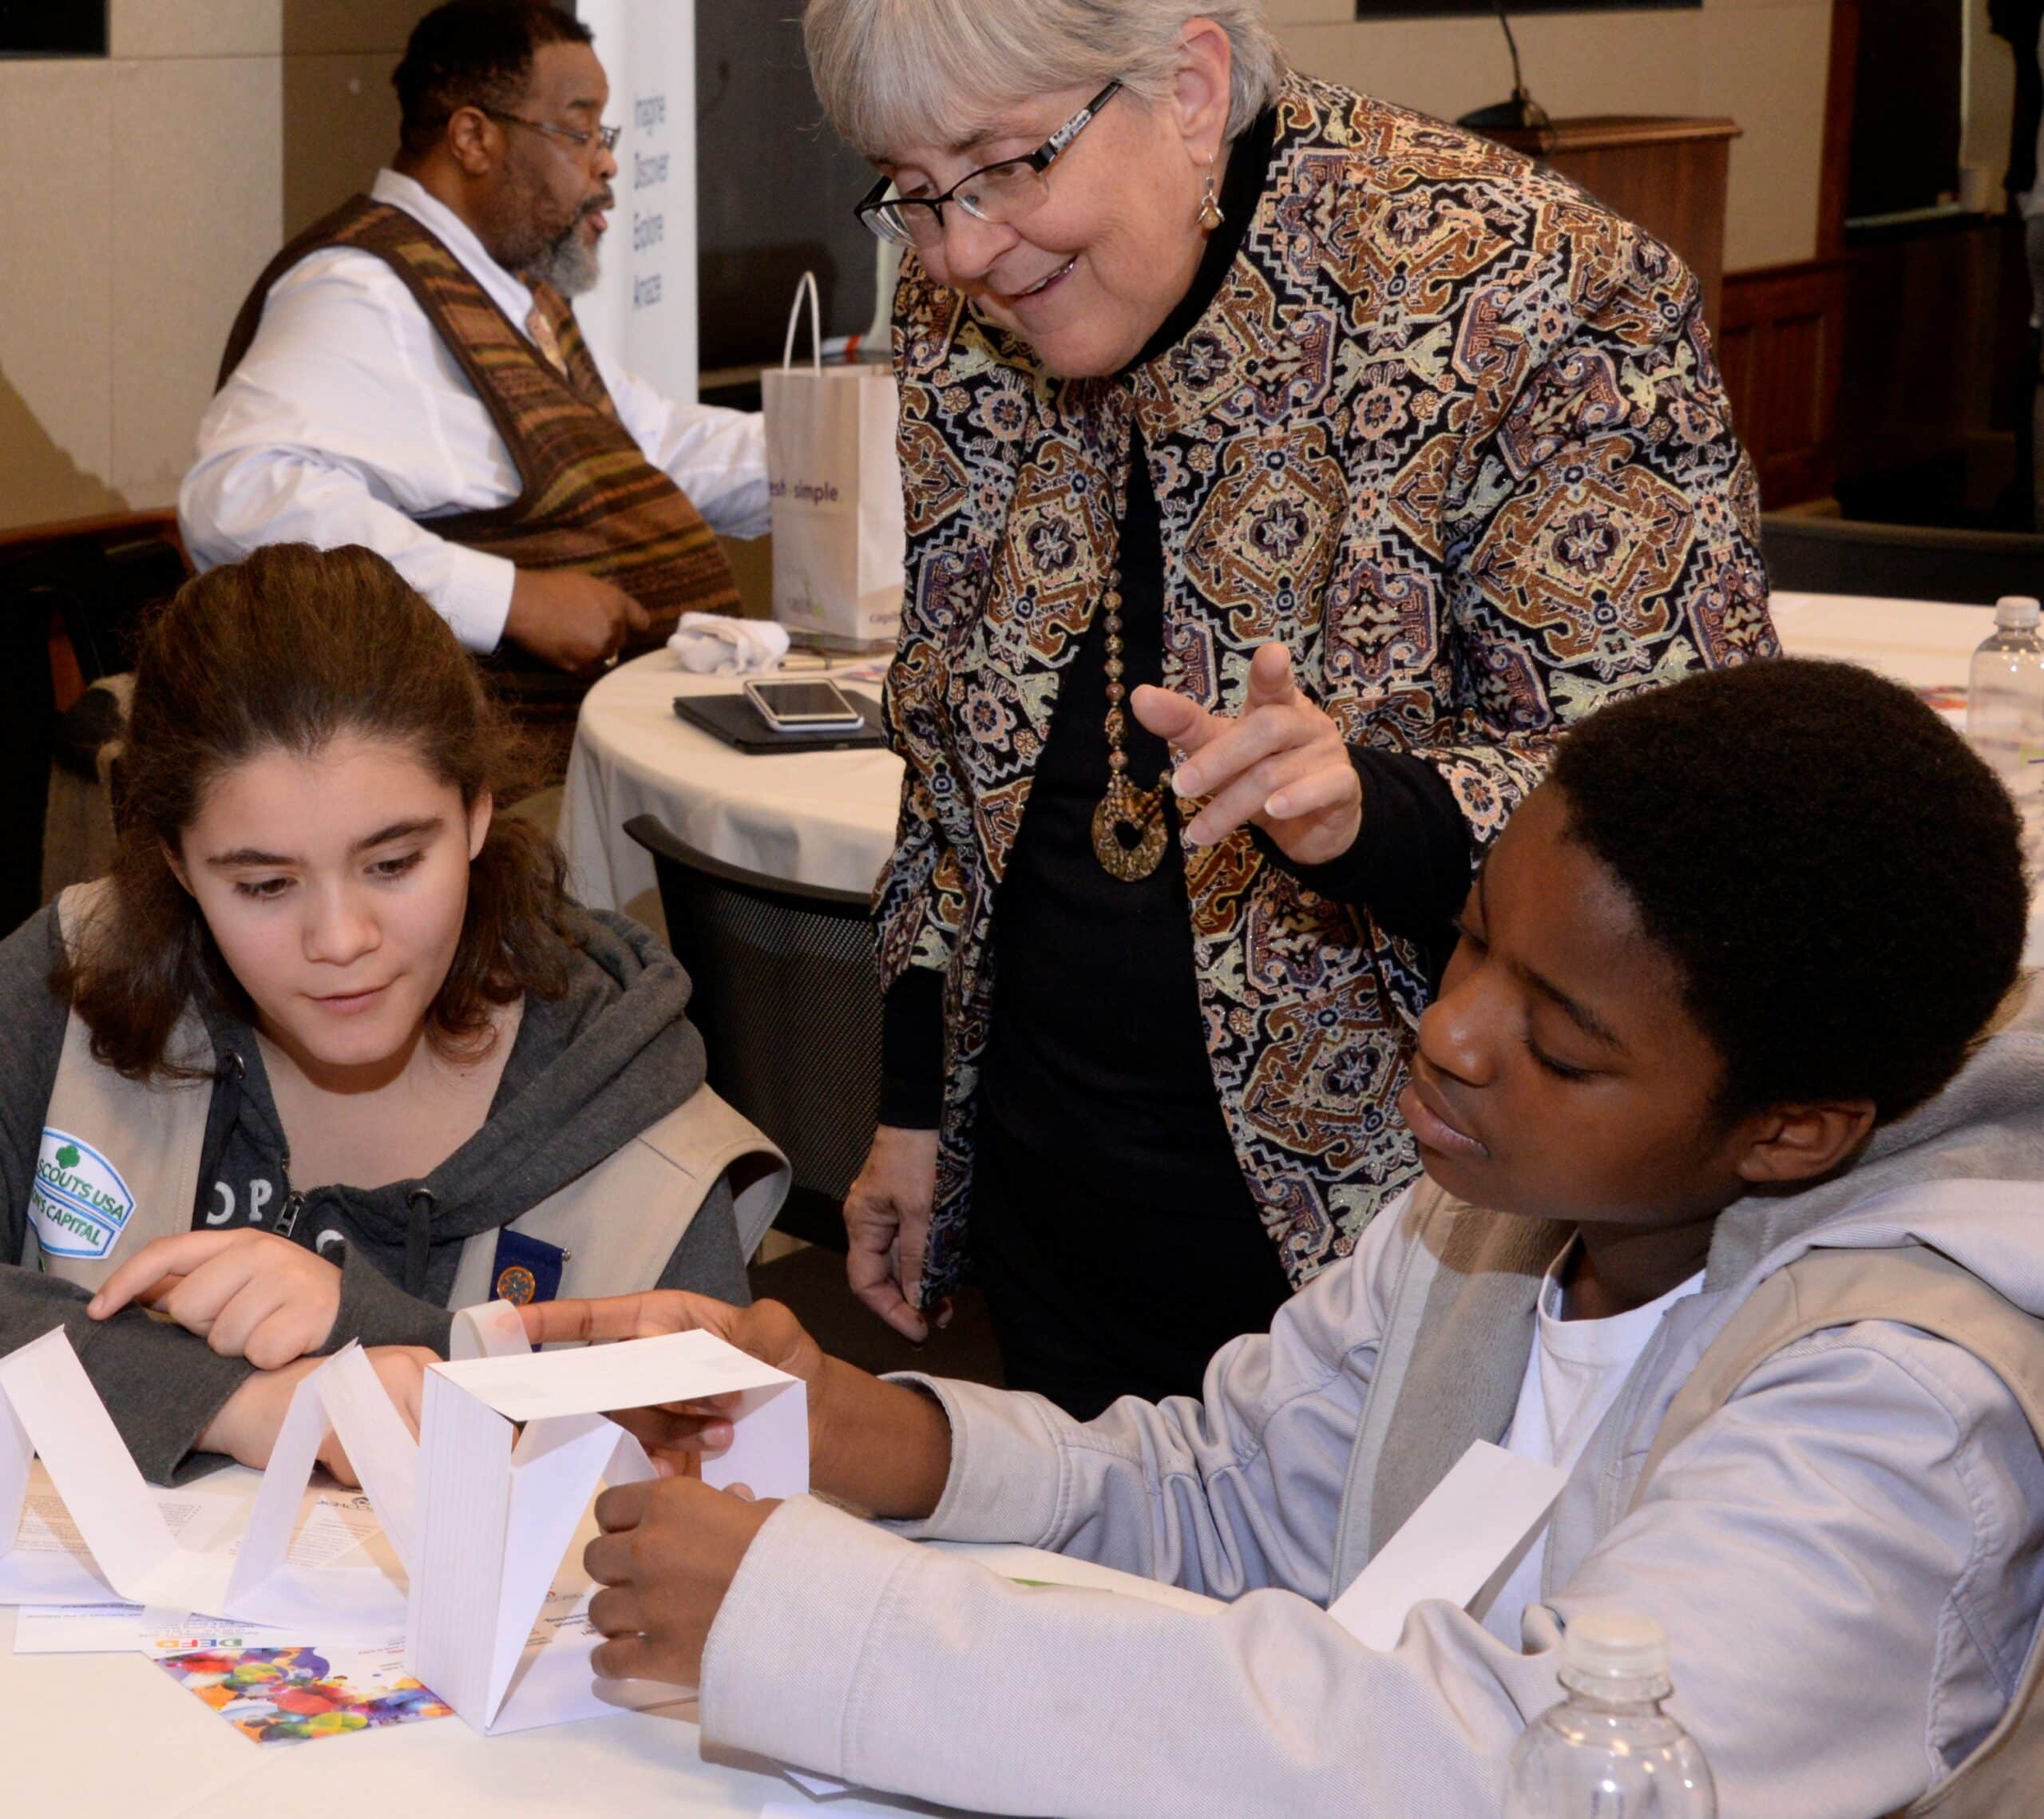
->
[1486,114,1740,329]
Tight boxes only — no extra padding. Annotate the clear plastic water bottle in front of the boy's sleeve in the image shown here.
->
[1504,1612,1717,1819]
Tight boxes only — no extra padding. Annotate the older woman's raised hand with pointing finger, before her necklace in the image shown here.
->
[1128,642,1364,865]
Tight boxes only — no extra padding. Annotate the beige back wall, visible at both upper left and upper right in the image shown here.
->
[0,0,1840,529]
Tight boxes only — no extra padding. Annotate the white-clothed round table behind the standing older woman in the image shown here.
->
[560,592,1993,925]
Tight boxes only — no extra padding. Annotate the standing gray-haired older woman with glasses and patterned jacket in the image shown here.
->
[822,0,1774,1417]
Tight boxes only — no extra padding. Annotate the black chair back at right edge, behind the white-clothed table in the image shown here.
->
[1760,513,2044,607]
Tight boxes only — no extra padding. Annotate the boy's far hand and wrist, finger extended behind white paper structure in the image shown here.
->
[519,1288,950,1516]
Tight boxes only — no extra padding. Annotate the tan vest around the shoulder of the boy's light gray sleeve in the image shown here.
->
[1633,1245,2044,1819]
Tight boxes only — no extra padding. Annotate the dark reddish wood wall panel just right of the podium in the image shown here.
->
[1717,260,1850,509]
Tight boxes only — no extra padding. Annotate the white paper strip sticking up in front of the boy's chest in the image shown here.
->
[1326,1441,1568,1650]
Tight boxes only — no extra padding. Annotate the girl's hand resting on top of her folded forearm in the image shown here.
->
[86,1228,342,1371]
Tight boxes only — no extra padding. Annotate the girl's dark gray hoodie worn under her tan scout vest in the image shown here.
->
[0,906,746,1482]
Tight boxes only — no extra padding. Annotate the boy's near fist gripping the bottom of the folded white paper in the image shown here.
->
[583,1478,781,1686]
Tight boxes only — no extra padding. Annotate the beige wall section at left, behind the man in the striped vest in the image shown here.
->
[0,0,430,529]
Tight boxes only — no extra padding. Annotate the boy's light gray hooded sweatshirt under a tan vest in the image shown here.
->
[701,977,2044,1819]
